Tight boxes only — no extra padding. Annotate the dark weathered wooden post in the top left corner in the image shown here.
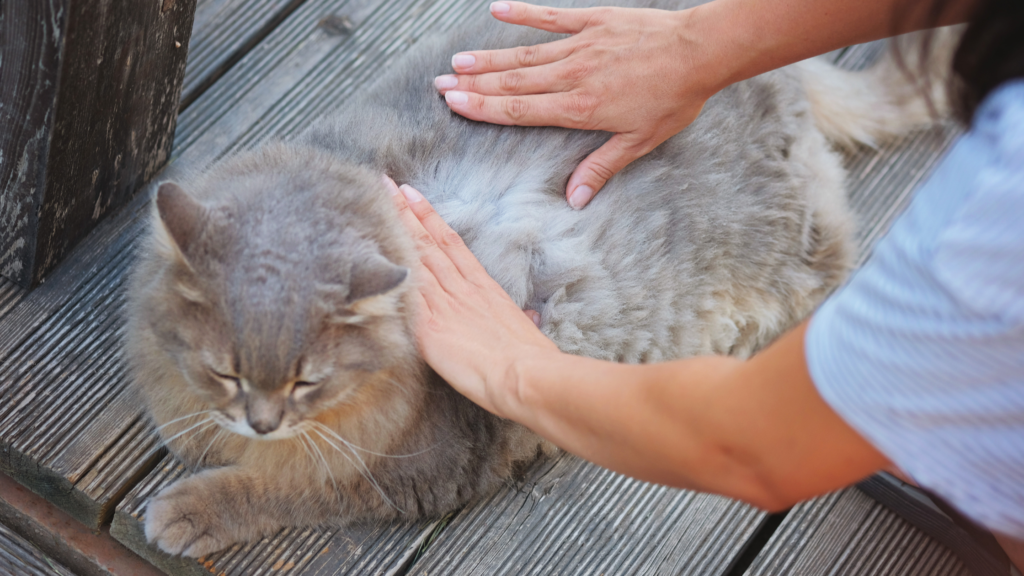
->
[0,0,196,287]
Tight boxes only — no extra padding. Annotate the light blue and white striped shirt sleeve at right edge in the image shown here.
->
[805,80,1024,539]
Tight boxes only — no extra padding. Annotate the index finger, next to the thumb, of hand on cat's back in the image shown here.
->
[444,90,597,130]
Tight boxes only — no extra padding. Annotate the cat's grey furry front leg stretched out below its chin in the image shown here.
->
[145,466,338,557]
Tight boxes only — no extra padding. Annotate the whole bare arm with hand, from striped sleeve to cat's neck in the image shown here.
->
[392,180,888,509]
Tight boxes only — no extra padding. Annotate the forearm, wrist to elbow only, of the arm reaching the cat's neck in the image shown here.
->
[507,344,766,503]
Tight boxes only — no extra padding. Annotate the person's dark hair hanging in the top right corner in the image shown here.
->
[894,0,1024,124]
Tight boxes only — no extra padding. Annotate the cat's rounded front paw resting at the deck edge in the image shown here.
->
[145,482,237,558]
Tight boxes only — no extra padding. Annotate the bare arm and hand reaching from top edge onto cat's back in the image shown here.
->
[435,0,974,208]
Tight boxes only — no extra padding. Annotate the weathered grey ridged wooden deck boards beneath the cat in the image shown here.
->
[0,0,981,576]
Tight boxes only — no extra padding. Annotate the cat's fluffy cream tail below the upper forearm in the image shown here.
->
[797,27,963,148]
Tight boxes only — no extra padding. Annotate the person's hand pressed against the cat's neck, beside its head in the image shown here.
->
[385,178,560,417]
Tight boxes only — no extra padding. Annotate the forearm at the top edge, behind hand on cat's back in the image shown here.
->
[681,0,975,92]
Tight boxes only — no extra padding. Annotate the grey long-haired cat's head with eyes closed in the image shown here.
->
[133,147,416,440]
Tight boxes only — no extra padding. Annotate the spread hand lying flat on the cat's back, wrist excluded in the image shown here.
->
[434,1,725,209]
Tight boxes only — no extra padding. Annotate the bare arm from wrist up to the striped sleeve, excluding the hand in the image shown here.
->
[503,317,886,509]
